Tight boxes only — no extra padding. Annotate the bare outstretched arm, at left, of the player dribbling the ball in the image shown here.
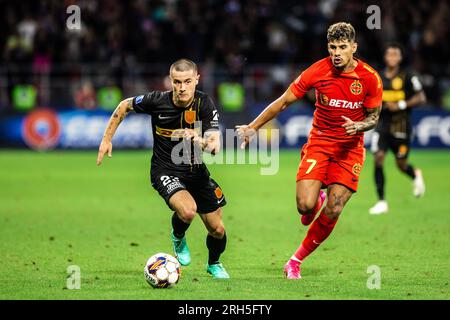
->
[97,98,133,166]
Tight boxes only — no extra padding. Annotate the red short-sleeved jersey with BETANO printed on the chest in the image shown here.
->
[290,57,383,142]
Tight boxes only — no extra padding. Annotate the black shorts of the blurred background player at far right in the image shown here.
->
[371,131,411,159]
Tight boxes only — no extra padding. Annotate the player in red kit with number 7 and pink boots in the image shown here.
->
[236,22,383,279]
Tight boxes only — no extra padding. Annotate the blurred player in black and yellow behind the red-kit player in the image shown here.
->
[369,43,426,214]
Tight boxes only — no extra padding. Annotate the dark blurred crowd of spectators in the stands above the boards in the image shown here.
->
[0,0,450,109]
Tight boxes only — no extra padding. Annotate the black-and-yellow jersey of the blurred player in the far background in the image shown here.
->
[377,69,422,138]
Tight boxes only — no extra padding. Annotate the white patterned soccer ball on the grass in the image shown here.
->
[144,253,181,288]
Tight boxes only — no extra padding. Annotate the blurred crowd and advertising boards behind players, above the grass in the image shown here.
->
[0,0,450,148]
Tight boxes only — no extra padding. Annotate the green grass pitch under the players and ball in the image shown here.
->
[0,150,450,300]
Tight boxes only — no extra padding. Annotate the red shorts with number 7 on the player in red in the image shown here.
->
[297,137,366,192]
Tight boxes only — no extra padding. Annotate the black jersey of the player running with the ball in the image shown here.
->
[133,91,219,172]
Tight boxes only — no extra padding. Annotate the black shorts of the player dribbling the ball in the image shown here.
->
[150,167,227,213]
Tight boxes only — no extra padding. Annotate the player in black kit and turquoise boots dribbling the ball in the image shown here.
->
[97,59,229,279]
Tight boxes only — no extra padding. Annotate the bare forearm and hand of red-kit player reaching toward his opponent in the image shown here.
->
[236,88,298,149]
